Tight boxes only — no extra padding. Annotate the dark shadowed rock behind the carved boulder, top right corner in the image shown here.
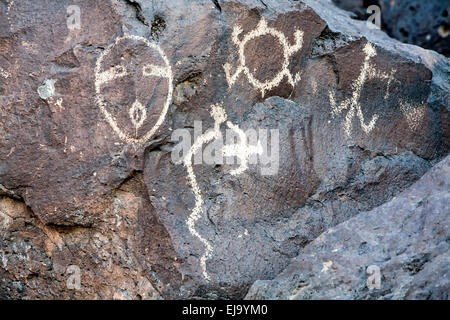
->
[333,0,450,57]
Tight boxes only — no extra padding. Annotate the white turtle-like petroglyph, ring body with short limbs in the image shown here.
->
[223,17,303,97]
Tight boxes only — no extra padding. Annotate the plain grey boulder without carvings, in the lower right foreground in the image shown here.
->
[246,157,450,300]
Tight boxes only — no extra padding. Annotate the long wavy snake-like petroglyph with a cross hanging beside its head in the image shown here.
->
[183,104,263,281]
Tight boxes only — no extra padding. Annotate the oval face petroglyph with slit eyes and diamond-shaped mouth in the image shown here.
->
[95,35,173,143]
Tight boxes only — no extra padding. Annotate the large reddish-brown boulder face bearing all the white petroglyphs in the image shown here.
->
[0,0,450,299]
